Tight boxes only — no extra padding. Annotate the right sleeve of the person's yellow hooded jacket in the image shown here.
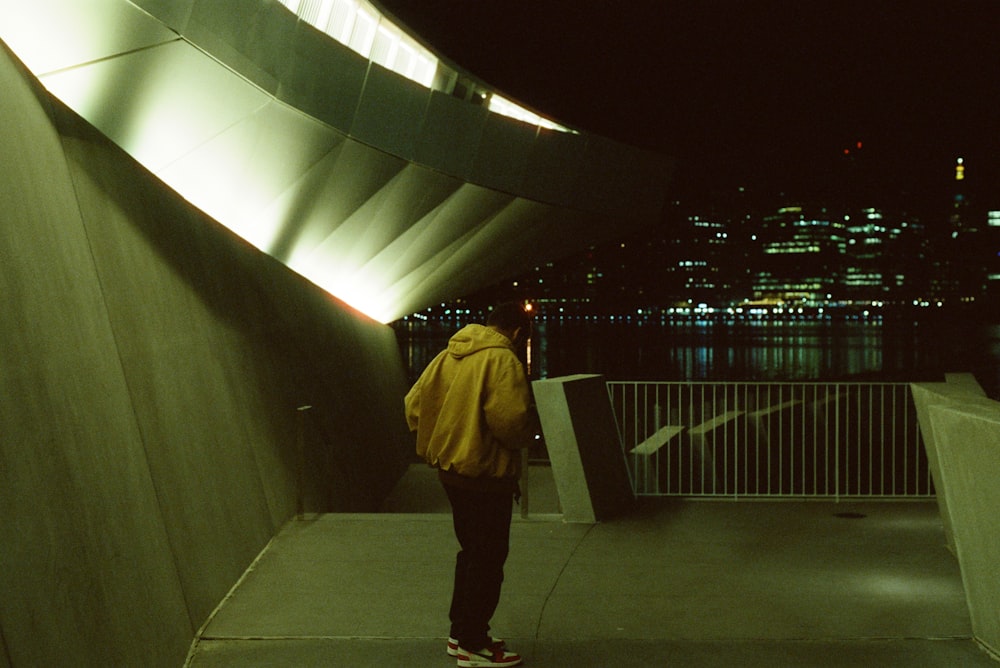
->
[483,351,536,450]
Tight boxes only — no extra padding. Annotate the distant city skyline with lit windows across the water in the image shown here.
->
[428,181,1000,319]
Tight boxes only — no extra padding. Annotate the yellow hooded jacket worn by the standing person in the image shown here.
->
[405,325,536,486]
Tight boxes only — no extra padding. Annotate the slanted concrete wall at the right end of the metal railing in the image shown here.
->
[913,383,1000,657]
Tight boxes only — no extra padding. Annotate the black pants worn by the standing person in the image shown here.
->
[443,484,513,650]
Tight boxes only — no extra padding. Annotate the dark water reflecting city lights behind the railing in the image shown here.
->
[396,319,1000,396]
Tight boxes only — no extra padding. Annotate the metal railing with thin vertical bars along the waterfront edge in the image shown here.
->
[608,382,934,498]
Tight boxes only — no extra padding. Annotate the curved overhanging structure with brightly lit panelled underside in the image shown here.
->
[0,0,668,322]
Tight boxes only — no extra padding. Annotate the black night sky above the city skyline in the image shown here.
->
[381,0,1000,214]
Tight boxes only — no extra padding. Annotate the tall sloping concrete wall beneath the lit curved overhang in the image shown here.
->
[0,45,411,666]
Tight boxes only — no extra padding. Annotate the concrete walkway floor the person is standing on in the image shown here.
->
[190,467,998,668]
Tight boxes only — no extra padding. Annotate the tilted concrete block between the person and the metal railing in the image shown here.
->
[532,374,634,522]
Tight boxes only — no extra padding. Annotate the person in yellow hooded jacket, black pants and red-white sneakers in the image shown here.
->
[405,303,538,668]
